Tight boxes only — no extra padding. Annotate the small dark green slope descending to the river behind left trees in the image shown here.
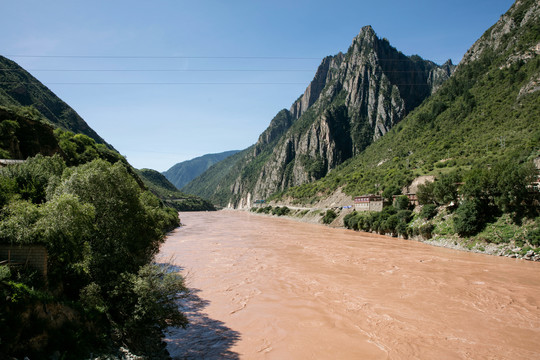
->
[136,169,216,211]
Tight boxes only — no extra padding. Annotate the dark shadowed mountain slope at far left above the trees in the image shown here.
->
[0,56,106,144]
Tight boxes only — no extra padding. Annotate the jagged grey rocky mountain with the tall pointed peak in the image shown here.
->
[185,26,454,207]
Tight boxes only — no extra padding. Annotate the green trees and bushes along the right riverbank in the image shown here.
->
[344,162,540,260]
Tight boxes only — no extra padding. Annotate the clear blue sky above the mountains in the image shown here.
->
[0,0,513,171]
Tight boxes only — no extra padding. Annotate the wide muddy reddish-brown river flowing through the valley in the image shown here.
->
[158,211,540,359]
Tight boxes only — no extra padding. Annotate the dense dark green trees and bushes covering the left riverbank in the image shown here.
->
[0,108,187,359]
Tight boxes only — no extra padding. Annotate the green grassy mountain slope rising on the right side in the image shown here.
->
[278,0,540,202]
